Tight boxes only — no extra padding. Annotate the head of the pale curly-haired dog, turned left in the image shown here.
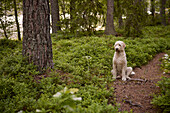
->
[114,41,126,52]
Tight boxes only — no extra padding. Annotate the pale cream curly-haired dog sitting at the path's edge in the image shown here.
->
[111,41,135,81]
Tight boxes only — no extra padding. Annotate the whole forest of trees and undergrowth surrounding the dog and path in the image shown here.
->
[0,0,170,113]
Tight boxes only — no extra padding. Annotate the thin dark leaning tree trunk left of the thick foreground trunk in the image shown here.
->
[14,0,21,40]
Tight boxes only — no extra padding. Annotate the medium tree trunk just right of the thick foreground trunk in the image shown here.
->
[50,0,61,33]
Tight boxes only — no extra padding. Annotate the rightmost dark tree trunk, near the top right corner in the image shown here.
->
[160,0,166,26]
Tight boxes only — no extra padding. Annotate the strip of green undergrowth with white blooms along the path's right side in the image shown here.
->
[151,51,170,113]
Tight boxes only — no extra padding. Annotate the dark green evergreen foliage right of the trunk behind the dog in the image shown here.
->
[123,0,147,37]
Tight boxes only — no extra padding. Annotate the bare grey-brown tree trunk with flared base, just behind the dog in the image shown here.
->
[105,0,116,35]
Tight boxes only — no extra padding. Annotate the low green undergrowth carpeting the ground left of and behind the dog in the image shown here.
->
[0,26,170,113]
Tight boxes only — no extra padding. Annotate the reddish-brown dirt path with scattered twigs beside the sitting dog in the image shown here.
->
[113,53,164,113]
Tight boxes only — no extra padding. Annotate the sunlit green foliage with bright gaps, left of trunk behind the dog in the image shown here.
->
[59,0,106,36]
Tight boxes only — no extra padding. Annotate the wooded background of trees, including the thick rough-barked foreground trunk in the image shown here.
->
[0,0,170,70]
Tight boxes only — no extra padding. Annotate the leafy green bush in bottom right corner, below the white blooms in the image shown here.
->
[151,77,170,113]
